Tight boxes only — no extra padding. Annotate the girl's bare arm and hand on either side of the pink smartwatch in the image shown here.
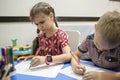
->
[30,46,71,67]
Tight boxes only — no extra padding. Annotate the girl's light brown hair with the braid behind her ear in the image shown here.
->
[30,2,58,27]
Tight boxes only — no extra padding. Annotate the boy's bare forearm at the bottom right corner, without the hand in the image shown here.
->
[99,72,120,80]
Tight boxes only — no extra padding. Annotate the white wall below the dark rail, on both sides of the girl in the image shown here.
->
[0,22,96,47]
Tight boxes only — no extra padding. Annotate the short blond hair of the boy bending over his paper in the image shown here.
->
[96,10,120,46]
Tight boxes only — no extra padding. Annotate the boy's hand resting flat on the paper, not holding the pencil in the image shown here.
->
[82,71,101,80]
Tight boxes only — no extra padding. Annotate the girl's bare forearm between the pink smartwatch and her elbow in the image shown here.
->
[52,53,71,63]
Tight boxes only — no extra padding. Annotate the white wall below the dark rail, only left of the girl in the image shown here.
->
[0,23,36,47]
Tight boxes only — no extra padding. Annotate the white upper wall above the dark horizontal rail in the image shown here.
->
[0,0,120,16]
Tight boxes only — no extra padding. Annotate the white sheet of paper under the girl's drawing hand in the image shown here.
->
[15,61,63,78]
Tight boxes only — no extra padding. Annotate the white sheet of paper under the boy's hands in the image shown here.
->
[60,64,108,80]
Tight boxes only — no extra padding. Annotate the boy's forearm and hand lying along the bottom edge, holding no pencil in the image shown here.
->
[83,71,120,80]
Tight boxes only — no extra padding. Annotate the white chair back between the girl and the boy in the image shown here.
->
[65,30,81,52]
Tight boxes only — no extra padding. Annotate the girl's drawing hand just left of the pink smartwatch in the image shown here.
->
[30,56,45,67]
